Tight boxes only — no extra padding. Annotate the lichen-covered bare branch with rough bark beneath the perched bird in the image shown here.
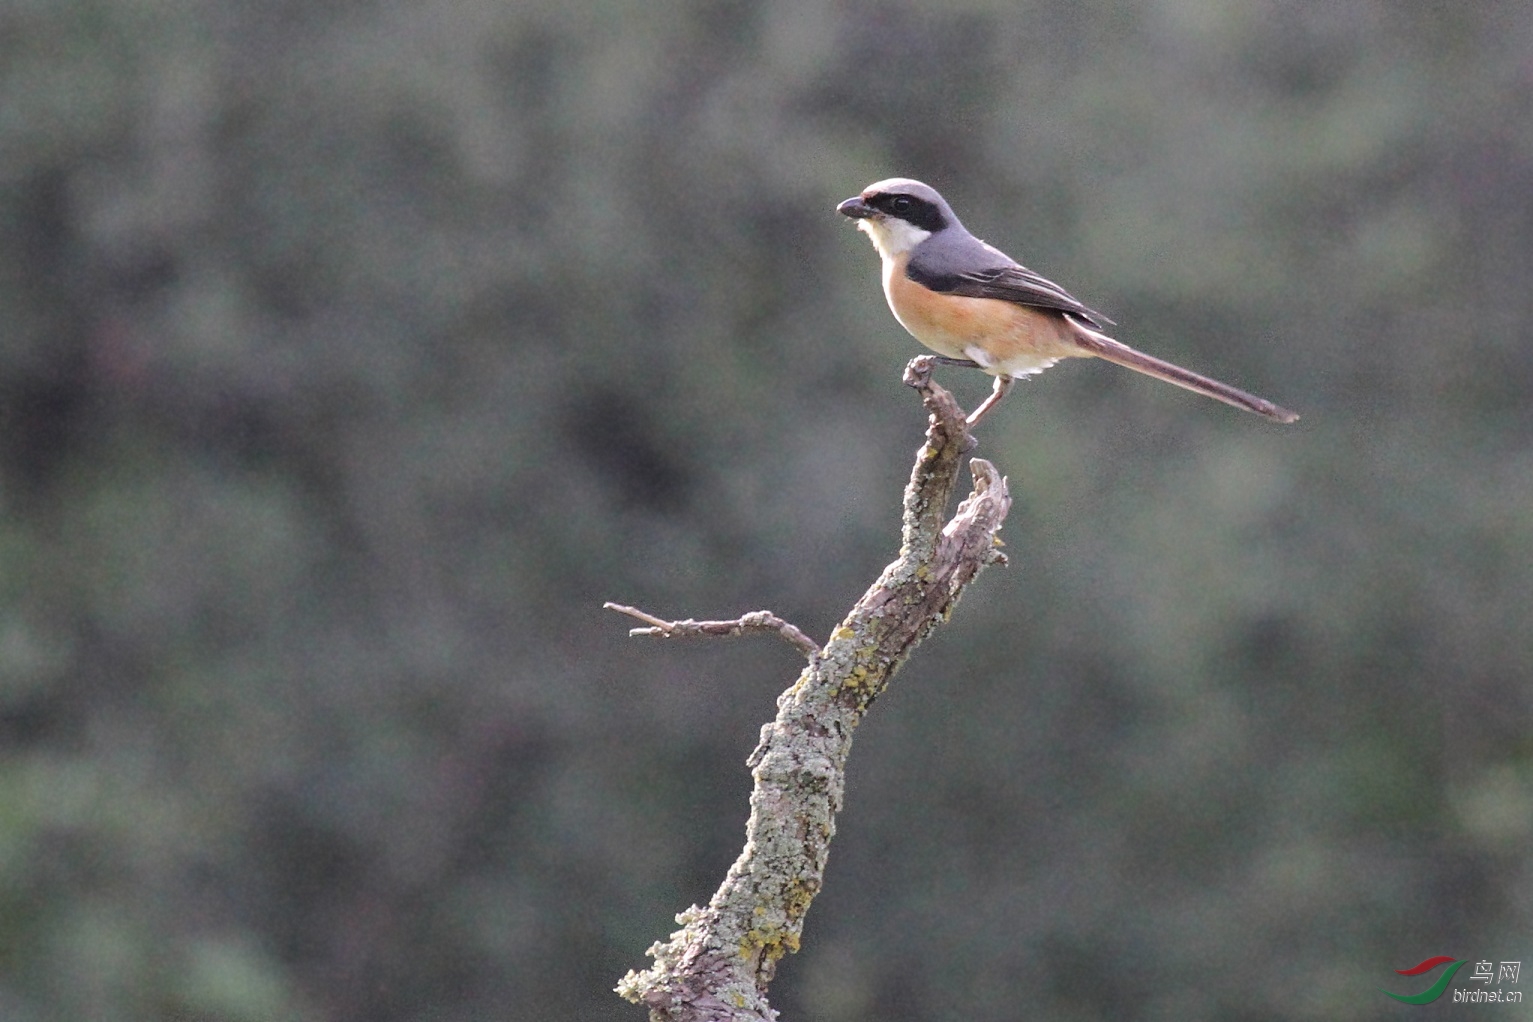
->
[618,357,1010,1020]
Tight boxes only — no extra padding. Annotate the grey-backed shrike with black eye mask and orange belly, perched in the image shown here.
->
[835,178,1298,427]
